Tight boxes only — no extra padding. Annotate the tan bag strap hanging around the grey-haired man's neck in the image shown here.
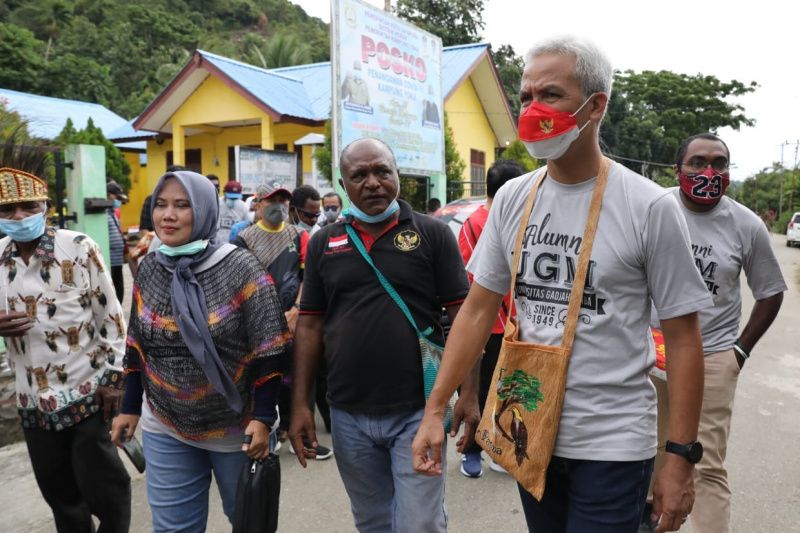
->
[506,156,611,352]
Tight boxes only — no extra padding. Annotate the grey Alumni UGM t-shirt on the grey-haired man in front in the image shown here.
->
[467,163,711,461]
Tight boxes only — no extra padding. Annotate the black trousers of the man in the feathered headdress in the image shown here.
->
[24,413,131,533]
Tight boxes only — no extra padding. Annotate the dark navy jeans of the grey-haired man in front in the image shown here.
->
[520,450,653,533]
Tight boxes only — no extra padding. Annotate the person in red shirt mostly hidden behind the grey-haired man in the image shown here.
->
[458,159,527,477]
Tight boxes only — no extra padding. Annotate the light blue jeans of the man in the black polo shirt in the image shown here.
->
[331,406,447,533]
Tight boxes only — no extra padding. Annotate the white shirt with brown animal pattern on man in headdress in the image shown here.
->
[0,228,125,431]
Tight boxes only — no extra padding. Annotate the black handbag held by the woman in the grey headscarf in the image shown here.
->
[233,453,281,533]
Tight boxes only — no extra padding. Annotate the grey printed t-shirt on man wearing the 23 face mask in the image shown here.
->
[670,187,786,355]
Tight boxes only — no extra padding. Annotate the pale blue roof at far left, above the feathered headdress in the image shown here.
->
[0,89,127,139]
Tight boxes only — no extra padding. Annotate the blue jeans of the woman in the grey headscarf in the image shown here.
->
[142,431,249,533]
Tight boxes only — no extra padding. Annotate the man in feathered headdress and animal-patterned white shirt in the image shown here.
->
[0,140,131,533]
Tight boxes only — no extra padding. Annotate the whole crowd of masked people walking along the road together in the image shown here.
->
[0,38,786,533]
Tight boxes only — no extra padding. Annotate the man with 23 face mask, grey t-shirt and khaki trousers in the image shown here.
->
[654,133,786,533]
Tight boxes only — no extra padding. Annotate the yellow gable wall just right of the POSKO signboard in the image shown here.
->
[444,78,497,187]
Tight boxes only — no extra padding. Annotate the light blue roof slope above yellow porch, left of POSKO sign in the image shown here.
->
[198,50,318,120]
